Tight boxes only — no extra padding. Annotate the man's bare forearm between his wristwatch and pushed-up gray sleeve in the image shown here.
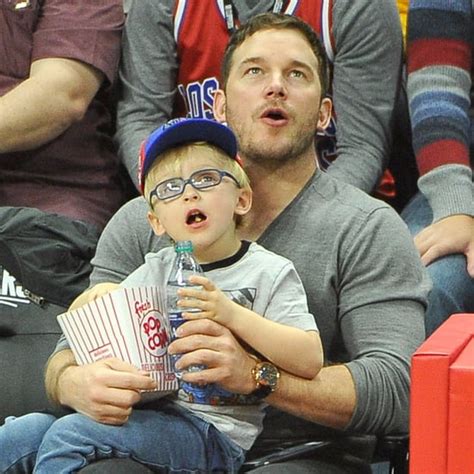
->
[266,365,356,429]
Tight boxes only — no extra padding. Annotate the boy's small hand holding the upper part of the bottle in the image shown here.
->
[178,275,239,328]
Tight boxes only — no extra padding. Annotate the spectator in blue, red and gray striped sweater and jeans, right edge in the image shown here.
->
[402,0,474,334]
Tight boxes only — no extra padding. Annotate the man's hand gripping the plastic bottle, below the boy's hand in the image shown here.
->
[168,319,255,394]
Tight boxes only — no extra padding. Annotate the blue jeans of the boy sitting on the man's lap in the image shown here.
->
[0,404,245,474]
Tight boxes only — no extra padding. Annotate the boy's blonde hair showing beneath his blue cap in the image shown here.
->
[144,142,250,202]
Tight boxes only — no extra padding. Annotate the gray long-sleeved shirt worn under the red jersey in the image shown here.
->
[116,0,402,193]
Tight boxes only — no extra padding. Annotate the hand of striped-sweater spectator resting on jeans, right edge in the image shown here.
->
[415,215,474,277]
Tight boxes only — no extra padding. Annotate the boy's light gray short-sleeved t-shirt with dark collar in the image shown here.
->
[122,243,317,449]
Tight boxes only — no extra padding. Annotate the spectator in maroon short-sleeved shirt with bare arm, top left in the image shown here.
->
[0,0,130,244]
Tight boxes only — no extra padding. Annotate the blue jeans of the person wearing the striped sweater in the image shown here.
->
[402,192,474,336]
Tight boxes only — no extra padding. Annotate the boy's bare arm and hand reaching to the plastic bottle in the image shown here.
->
[178,276,323,379]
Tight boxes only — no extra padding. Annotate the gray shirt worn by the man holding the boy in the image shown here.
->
[85,172,429,438]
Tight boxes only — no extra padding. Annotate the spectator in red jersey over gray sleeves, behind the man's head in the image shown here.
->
[116,0,402,200]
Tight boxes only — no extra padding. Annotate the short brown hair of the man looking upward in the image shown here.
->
[221,13,329,97]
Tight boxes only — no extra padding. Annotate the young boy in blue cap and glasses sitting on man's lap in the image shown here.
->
[20,119,323,474]
